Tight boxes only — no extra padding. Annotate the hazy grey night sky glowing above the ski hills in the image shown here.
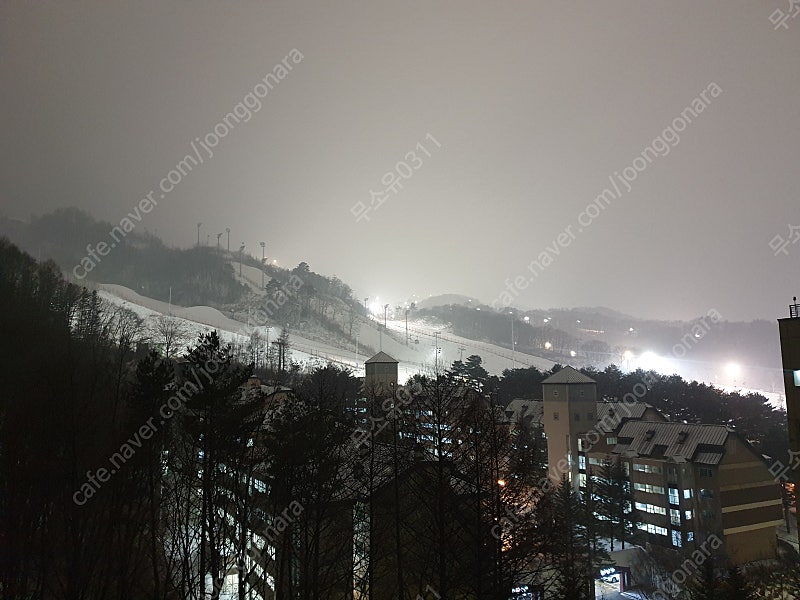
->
[0,0,800,320]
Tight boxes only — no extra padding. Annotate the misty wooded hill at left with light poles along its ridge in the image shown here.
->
[0,208,374,351]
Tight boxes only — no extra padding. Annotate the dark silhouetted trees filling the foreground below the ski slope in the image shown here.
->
[0,240,794,600]
